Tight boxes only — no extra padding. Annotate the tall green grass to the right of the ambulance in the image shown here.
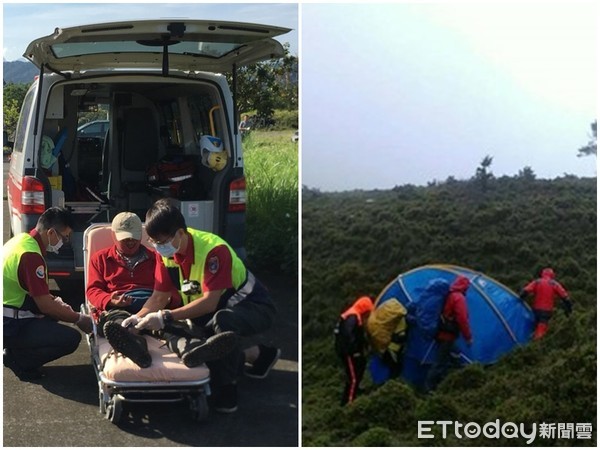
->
[244,130,298,276]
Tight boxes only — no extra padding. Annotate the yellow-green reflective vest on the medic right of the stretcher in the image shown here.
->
[162,228,246,305]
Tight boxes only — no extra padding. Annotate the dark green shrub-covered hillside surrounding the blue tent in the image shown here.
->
[302,176,597,446]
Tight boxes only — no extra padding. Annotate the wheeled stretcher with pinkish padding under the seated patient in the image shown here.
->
[82,223,210,424]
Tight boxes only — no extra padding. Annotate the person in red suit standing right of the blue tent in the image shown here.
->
[519,267,573,339]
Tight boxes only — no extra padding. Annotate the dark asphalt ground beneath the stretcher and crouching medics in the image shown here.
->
[3,163,299,447]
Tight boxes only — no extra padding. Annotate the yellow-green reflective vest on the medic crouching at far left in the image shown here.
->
[2,233,48,309]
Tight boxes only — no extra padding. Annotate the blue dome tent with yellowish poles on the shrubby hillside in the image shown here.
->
[371,265,534,386]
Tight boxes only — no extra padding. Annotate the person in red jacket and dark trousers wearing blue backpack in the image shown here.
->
[425,275,473,392]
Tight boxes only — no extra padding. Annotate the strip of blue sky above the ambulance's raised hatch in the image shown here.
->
[2,1,299,61]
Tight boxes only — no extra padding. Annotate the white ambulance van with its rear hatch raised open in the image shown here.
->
[7,20,290,285]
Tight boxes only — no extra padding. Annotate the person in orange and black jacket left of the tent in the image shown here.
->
[335,297,373,406]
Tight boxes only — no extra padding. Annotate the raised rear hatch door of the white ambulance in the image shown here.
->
[23,20,290,74]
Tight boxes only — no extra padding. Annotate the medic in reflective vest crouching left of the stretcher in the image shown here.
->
[2,207,92,381]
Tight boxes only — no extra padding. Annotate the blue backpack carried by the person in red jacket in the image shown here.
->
[409,278,450,339]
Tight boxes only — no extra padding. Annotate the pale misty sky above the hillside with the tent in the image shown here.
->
[301,1,598,191]
